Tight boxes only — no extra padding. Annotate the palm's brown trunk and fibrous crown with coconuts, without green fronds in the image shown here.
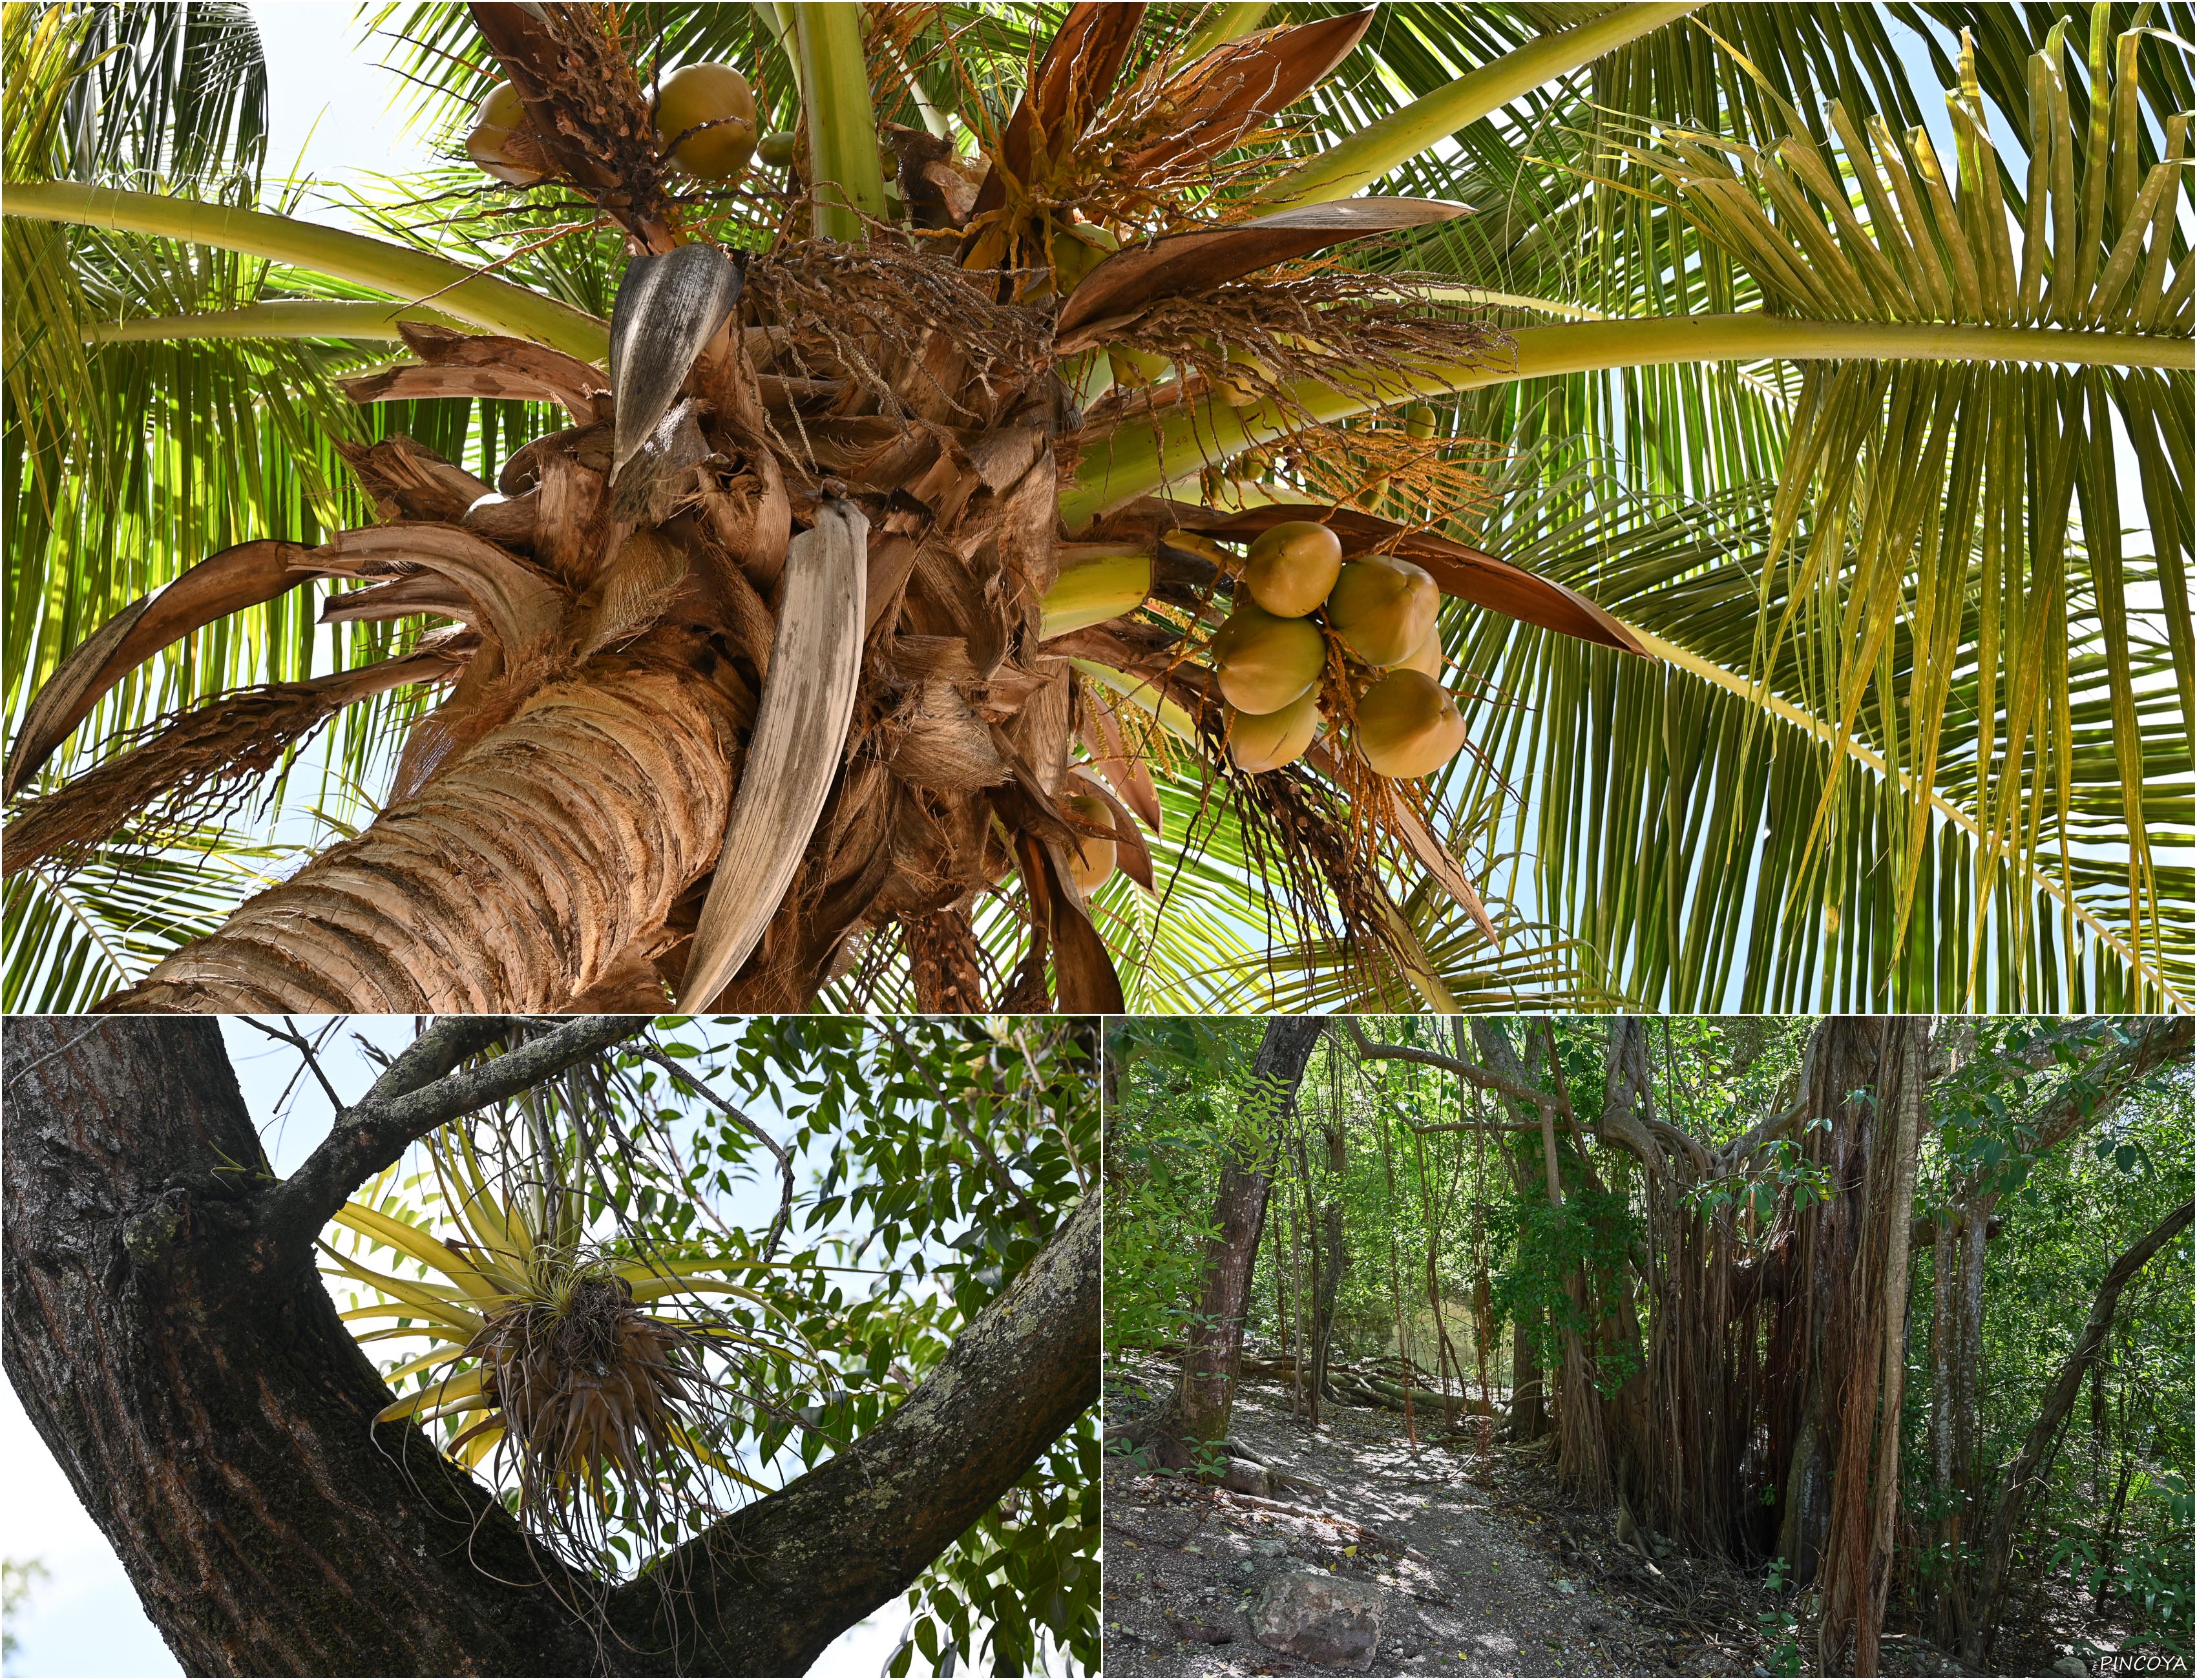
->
[6,5,1641,1013]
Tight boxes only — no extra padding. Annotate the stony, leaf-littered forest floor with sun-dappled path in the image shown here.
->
[1105,1364,2030,1675]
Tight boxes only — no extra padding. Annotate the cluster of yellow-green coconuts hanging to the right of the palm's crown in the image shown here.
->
[1164,520,1466,777]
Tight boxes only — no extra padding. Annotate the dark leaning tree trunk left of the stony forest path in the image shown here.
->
[1158,1014,1323,1441]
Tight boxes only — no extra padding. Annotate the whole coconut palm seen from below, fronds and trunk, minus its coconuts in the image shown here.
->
[5,5,2197,1010]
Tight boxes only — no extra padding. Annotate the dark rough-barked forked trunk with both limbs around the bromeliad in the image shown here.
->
[5,1017,1098,1675]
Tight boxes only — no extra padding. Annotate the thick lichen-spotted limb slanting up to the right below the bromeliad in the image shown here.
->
[613,1197,1100,1674]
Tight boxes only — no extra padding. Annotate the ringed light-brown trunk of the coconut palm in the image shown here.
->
[108,656,745,1014]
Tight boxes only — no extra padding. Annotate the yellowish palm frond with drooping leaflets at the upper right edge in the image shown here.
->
[1599,11,2192,999]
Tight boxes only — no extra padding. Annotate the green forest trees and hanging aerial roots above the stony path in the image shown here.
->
[1105,1017,2197,1674]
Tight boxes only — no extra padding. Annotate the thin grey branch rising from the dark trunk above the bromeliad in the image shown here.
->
[262,1014,650,1245]
